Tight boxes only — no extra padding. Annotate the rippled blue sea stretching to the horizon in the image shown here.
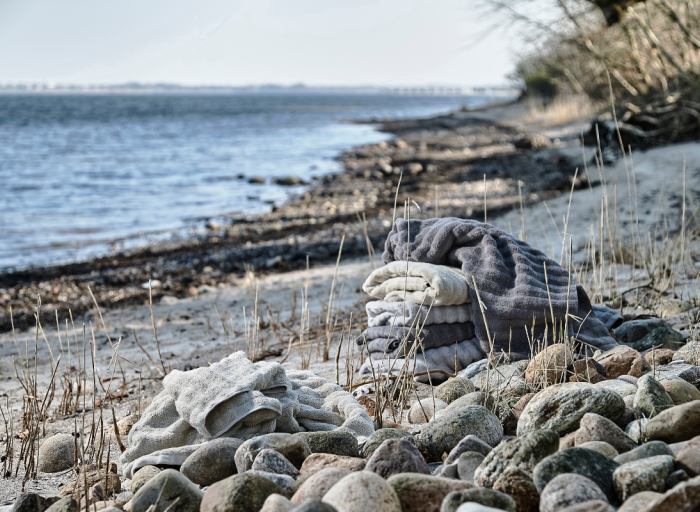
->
[0,93,504,272]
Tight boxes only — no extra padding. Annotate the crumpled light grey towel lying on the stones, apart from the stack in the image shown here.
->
[120,352,374,478]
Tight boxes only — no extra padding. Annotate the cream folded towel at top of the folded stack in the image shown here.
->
[362,261,469,306]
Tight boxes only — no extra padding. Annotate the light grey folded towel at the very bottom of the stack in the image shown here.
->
[360,338,485,383]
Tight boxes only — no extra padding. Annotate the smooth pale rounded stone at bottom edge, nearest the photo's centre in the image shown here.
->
[323,471,406,512]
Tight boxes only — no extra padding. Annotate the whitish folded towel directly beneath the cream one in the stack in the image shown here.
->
[365,300,471,327]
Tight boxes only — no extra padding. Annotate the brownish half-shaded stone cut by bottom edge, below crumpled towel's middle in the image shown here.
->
[198,474,284,512]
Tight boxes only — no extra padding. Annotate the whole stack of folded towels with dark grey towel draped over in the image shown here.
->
[356,218,622,382]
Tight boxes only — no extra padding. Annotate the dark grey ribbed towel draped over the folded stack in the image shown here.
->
[383,218,617,359]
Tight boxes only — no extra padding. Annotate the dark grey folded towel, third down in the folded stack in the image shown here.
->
[355,322,474,357]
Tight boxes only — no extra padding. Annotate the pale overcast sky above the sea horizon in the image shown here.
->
[0,0,517,85]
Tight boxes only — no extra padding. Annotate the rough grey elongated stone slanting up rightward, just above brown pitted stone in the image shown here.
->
[474,429,559,488]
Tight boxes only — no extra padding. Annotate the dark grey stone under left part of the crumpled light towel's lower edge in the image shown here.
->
[179,437,243,486]
